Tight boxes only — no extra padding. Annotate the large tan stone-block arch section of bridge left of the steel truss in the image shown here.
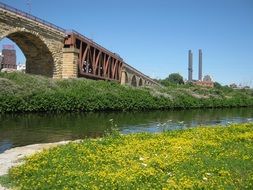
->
[0,9,65,78]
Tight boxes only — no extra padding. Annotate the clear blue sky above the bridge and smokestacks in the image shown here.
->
[0,0,253,86]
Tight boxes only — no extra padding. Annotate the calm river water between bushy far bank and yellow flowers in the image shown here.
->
[0,108,253,153]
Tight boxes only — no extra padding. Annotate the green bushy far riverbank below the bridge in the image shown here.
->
[0,73,253,113]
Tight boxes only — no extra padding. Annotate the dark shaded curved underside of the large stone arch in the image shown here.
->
[1,30,54,77]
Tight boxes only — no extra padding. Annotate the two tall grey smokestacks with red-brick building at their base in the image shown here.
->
[188,49,214,88]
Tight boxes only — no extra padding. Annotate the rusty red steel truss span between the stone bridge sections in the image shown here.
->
[64,31,123,82]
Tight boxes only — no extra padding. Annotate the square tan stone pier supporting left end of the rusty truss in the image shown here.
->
[62,47,79,78]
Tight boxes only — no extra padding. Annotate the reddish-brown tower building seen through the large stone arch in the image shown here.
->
[1,45,17,70]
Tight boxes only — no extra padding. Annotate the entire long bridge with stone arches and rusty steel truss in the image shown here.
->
[0,3,158,86]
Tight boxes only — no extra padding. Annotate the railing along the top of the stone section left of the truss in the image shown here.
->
[0,2,65,33]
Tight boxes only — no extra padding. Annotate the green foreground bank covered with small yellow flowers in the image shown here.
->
[3,123,253,189]
